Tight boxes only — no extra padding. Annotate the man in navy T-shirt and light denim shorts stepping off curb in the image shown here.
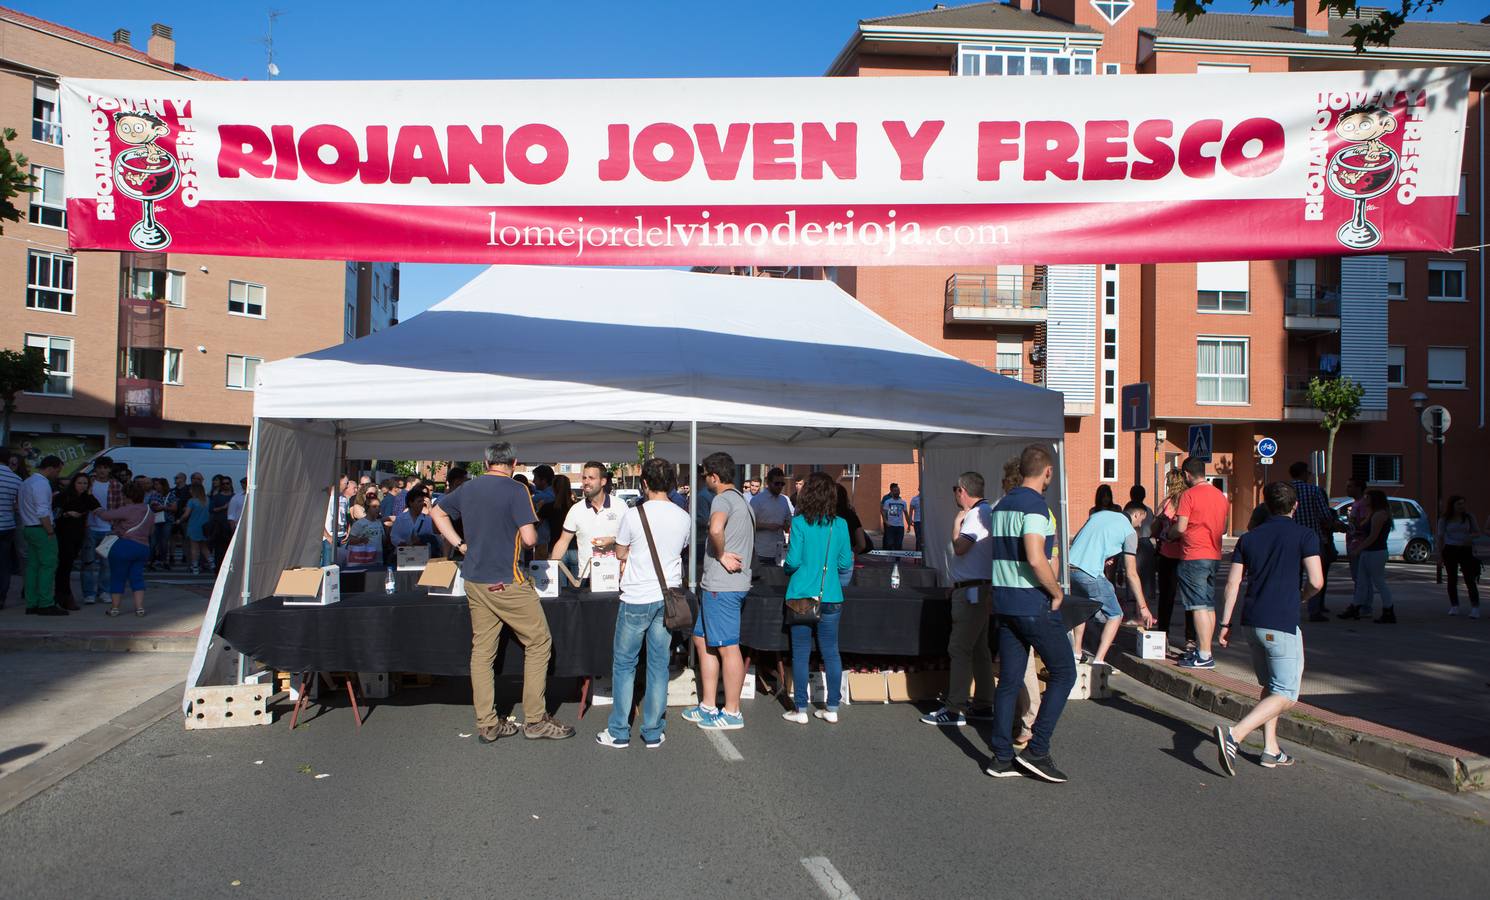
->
[1216,481,1325,775]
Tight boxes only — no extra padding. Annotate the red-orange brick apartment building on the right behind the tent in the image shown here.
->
[825,0,1490,530]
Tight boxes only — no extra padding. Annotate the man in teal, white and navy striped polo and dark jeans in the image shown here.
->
[985,444,1076,784]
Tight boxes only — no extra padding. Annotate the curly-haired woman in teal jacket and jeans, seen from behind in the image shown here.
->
[782,472,854,726]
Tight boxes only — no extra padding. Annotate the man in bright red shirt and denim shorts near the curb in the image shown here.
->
[1170,457,1231,669]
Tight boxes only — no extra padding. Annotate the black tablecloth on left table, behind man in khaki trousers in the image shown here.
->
[218,592,620,676]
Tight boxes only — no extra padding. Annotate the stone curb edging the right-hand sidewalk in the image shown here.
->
[1113,653,1490,793]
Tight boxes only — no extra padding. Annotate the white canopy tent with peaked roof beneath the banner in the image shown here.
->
[188,267,1065,697]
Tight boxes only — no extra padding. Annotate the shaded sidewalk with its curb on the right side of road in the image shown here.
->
[1113,562,1490,790]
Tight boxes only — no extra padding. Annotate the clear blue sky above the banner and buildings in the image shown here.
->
[26,0,1487,319]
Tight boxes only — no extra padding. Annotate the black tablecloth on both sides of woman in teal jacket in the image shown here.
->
[741,586,952,656]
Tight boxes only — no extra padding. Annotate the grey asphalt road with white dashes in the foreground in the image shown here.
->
[0,679,1490,900]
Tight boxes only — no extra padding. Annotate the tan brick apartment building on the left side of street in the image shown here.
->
[0,7,398,465]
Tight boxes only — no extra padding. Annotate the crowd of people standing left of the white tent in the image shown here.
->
[0,449,247,615]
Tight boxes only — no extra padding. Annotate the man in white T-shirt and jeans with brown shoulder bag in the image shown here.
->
[595,457,694,750]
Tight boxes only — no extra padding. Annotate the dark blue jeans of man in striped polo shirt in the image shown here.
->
[991,611,1076,760]
